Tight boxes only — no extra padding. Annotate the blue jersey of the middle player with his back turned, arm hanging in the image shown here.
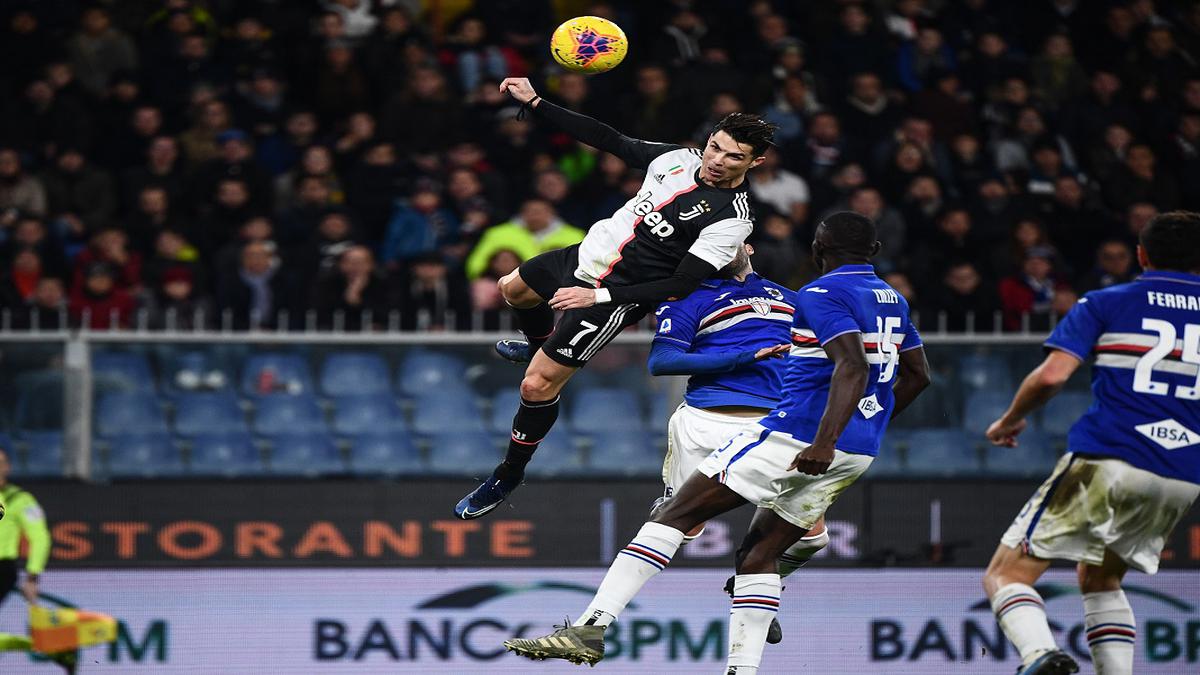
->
[762,265,922,456]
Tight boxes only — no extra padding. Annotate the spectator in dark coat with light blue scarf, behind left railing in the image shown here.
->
[217,241,293,330]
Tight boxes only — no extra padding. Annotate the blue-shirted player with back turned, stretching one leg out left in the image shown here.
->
[504,213,929,675]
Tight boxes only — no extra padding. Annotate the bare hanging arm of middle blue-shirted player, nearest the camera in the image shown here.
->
[788,333,871,476]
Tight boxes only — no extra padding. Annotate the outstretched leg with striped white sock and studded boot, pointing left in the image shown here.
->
[504,473,745,664]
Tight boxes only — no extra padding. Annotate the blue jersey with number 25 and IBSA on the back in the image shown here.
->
[1046,271,1200,483]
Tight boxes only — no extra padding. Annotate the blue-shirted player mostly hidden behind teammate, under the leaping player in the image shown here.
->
[649,244,829,644]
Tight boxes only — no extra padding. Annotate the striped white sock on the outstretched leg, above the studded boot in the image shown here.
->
[575,522,686,626]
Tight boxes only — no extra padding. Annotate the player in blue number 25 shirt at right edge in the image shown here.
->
[984,211,1200,675]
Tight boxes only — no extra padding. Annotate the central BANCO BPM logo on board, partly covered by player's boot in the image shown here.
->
[312,580,725,665]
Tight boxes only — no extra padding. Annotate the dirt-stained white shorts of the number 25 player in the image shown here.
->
[1001,453,1200,574]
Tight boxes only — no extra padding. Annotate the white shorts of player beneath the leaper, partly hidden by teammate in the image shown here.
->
[662,404,762,497]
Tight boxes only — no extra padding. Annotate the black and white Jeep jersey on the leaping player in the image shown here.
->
[535,101,754,287]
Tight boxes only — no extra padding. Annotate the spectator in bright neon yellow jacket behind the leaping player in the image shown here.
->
[466,198,583,280]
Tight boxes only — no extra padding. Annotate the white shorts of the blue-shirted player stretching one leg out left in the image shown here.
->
[697,424,875,530]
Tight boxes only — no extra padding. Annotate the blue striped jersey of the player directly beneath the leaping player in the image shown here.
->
[654,274,796,408]
